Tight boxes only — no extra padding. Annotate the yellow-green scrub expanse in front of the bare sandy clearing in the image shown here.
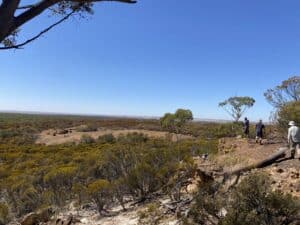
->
[0,113,217,223]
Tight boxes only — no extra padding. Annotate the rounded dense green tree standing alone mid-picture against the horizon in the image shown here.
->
[160,109,194,134]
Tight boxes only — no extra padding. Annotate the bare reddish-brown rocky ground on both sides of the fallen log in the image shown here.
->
[215,138,300,197]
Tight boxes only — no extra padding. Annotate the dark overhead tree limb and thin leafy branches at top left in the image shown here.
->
[0,0,137,49]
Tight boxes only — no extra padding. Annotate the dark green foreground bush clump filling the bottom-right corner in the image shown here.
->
[188,172,300,225]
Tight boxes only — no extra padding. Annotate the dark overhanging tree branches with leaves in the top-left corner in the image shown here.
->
[0,0,136,50]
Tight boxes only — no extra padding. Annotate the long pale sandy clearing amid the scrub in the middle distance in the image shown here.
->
[36,128,192,145]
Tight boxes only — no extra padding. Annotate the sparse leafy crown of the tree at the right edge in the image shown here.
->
[264,76,300,108]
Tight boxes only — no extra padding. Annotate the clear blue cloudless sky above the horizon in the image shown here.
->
[0,0,300,120]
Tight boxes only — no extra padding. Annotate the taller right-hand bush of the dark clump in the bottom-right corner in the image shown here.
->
[221,173,300,225]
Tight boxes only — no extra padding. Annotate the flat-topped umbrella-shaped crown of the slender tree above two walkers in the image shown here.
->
[219,96,255,122]
